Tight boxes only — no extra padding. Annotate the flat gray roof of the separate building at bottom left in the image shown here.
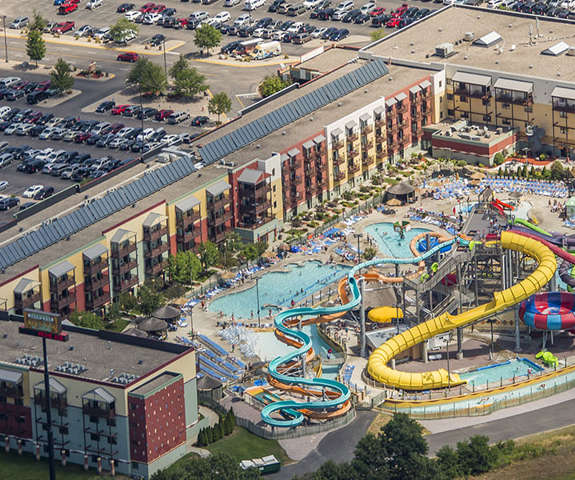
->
[0,321,185,382]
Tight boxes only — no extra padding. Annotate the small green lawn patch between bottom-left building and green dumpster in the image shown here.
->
[205,427,290,464]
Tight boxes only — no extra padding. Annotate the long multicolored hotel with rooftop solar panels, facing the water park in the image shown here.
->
[0,6,575,316]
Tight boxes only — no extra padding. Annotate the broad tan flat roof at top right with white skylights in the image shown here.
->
[364,6,575,82]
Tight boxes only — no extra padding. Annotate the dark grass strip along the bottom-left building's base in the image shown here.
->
[0,451,122,480]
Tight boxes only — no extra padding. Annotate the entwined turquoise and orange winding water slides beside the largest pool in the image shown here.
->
[261,237,467,427]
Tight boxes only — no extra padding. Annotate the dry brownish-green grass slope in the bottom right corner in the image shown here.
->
[473,426,575,480]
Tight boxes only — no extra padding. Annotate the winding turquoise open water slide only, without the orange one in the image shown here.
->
[261,237,468,428]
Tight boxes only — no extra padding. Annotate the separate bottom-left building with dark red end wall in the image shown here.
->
[0,321,199,478]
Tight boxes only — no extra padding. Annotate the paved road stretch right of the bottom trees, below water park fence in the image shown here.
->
[426,400,575,454]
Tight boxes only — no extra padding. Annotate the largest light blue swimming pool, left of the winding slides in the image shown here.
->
[208,261,350,319]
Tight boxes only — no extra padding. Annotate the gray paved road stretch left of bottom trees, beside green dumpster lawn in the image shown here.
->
[269,411,376,480]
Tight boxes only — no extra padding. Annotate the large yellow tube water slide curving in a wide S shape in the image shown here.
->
[367,232,557,390]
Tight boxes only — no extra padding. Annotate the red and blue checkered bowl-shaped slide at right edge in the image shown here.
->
[519,292,575,330]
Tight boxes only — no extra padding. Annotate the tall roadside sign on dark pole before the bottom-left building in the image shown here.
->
[19,308,69,480]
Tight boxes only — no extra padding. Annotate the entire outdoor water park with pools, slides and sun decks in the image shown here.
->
[179,175,575,439]
